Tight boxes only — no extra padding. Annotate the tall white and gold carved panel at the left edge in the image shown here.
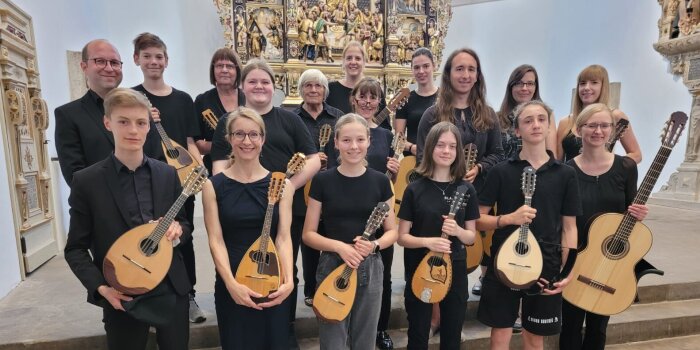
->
[0,0,57,273]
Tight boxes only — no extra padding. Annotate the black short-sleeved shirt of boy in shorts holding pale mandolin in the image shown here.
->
[479,151,582,278]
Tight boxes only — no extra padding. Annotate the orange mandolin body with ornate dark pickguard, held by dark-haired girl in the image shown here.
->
[411,252,452,304]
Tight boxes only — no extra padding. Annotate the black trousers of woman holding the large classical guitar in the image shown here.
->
[559,300,610,350]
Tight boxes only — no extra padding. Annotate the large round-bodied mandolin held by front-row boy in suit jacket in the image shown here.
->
[102,166,208,295]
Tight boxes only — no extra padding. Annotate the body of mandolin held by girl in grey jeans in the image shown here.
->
[313,264,357,323]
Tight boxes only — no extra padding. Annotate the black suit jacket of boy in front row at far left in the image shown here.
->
[64,157,192,305]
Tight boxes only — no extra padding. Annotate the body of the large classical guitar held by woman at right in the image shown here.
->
[563,213,653,316]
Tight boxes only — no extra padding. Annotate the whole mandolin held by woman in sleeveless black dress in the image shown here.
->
[235,172,287,302]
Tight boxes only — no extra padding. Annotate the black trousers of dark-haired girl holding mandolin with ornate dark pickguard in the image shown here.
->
[404,260,469,350]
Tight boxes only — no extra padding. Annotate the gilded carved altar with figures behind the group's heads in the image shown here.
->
[214,0,452,105]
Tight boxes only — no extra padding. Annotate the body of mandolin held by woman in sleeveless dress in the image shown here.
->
[235,237,281,301]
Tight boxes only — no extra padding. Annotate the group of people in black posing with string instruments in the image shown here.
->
[55,33,648,349]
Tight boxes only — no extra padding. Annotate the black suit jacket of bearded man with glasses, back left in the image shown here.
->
[54,91,164,186]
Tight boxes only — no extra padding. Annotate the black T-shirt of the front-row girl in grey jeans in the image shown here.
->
[309,168,393,243]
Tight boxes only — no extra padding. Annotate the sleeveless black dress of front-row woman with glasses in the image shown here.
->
[211,173,290,349]
